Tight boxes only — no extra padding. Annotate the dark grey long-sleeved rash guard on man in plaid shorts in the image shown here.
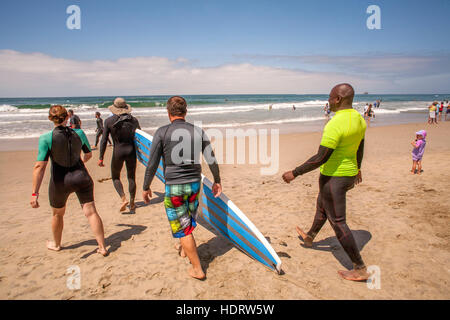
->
[143,119,220,190]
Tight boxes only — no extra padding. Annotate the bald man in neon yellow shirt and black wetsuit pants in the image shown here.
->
[283,83,369,281]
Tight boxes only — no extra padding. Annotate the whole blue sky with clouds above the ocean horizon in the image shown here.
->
[0,0,450,97]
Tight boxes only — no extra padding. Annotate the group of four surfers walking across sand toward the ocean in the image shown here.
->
[30,83,369,281]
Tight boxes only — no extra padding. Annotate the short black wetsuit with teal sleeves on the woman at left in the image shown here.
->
[37,126,94,208]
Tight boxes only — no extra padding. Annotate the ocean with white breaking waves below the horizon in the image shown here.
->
[0,94,444,140]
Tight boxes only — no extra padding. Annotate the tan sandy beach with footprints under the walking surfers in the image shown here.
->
[0,121,450,300]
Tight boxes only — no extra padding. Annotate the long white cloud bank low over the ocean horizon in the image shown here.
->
[0,50,448,97]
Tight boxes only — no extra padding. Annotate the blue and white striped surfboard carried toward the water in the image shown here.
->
[135,130,281,273]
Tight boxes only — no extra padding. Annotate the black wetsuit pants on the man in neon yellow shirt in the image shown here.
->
[308,174,364,269]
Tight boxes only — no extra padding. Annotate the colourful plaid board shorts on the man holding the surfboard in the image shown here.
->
[164,182,200,238]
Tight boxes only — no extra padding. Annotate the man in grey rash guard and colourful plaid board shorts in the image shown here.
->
[142,96,222,279]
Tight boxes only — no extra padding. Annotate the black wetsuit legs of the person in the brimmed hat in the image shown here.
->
[111,143,136,201]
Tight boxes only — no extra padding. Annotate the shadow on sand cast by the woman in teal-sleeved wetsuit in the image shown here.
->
[62,224,147,259]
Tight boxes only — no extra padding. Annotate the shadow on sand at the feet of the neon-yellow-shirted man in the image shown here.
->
[298,230,372,270]
